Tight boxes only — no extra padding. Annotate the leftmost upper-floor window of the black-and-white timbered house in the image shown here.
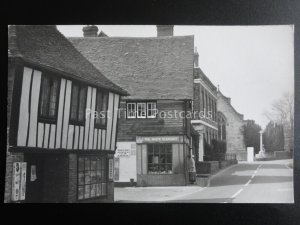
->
[39,74,59,120]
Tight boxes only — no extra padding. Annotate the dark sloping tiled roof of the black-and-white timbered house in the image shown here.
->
[8,25,128,95]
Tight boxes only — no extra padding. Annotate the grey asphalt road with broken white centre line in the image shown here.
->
[168,160,294,203]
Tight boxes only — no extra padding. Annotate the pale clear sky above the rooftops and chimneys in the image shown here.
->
[57,25,294,128]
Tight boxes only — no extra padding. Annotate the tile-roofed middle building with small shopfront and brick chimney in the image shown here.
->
[70,26,194,186]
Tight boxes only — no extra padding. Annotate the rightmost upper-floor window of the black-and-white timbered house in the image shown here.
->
[95,90,108,128]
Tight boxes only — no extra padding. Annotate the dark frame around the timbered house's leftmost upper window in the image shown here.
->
[37,72,61,124]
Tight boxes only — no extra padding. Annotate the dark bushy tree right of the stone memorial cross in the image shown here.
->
[263,121,284,152]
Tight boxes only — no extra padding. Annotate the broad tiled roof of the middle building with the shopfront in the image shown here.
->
[69,36,194,99]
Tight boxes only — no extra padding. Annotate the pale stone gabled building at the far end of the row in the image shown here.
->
[217,91,247,160]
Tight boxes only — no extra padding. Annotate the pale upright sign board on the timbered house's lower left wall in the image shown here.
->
[12,162,27,201]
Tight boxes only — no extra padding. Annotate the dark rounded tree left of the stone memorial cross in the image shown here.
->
[241,120,261,153]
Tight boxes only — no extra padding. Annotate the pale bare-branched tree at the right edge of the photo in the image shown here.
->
[264,92,294,150]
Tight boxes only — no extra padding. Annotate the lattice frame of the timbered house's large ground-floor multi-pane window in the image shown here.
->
[76,155,109,201]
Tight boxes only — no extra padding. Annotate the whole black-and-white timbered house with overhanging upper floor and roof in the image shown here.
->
[5,26,128,203]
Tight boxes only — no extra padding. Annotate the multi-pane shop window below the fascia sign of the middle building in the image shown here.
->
[147,144,172,174]
